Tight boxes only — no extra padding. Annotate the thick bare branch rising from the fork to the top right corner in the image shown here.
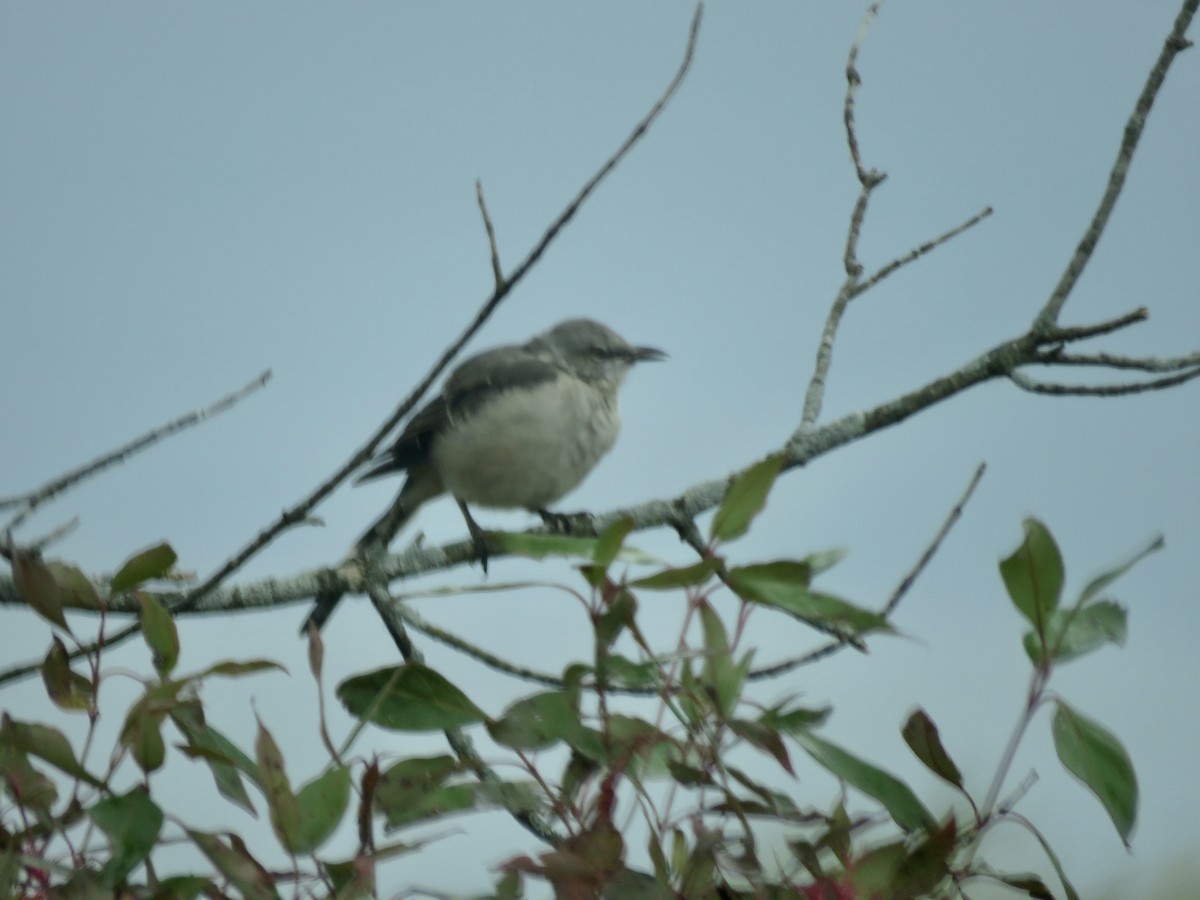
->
[1033,0,1200,334]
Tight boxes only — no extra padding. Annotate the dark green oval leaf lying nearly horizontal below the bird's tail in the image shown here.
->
[337,662,487,731]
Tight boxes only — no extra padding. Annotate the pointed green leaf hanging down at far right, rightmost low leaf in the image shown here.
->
[1052,700,1138,846]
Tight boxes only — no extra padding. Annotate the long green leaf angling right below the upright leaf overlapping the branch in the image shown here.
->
[726,560,893,635]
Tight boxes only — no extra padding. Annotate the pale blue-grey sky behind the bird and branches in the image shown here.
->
[0,0,1200,898]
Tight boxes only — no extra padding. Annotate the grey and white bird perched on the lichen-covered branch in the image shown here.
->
[301,319,666,631]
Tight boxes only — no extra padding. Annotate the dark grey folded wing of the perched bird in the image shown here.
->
[358,347,562,481]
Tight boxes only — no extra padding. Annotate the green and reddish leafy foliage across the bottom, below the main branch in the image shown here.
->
[0,504,1160,900]
